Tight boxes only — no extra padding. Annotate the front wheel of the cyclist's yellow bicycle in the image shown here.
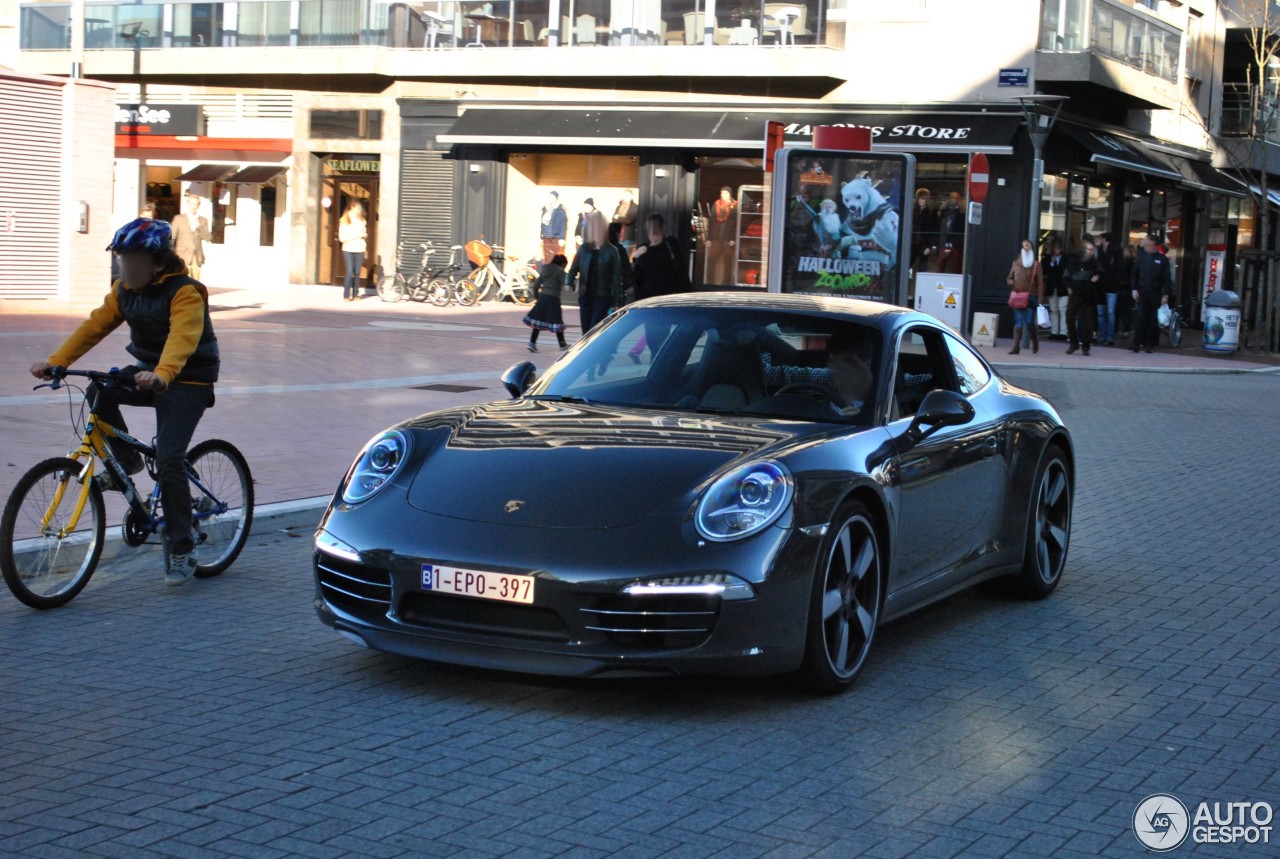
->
[0,457,106,608]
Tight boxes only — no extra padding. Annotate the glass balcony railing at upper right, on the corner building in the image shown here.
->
[1039,0,1183,82]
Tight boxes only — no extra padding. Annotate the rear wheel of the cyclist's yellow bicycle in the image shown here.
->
[187,439,253,579]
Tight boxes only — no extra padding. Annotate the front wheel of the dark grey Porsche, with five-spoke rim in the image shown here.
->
[800,502,886,695]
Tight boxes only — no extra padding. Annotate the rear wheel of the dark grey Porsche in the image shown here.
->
[1010,444,1071,599]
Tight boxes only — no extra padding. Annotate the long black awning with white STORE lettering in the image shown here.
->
[438,108,1021,155]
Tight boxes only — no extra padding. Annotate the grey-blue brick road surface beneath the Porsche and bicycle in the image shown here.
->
[0,353,1280,859]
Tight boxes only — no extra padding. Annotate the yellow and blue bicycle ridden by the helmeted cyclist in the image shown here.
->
[0,367,253,608]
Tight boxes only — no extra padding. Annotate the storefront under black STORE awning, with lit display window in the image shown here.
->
[419,102,1030,317]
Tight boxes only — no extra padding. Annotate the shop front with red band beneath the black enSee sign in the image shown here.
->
[113,104,293,285]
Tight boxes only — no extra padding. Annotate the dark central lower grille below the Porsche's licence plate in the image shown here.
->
[398,591,572,643]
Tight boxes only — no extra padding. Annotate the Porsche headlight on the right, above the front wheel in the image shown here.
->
[694,460,792,542]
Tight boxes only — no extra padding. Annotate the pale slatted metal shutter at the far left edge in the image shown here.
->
[0,77,63,298]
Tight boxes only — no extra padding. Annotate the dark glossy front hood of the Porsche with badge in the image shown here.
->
[402,399,829,529]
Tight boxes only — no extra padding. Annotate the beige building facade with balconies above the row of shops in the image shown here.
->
[12,0,1248,332]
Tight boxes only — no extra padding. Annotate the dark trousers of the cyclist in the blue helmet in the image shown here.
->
[95,381,214,554]
